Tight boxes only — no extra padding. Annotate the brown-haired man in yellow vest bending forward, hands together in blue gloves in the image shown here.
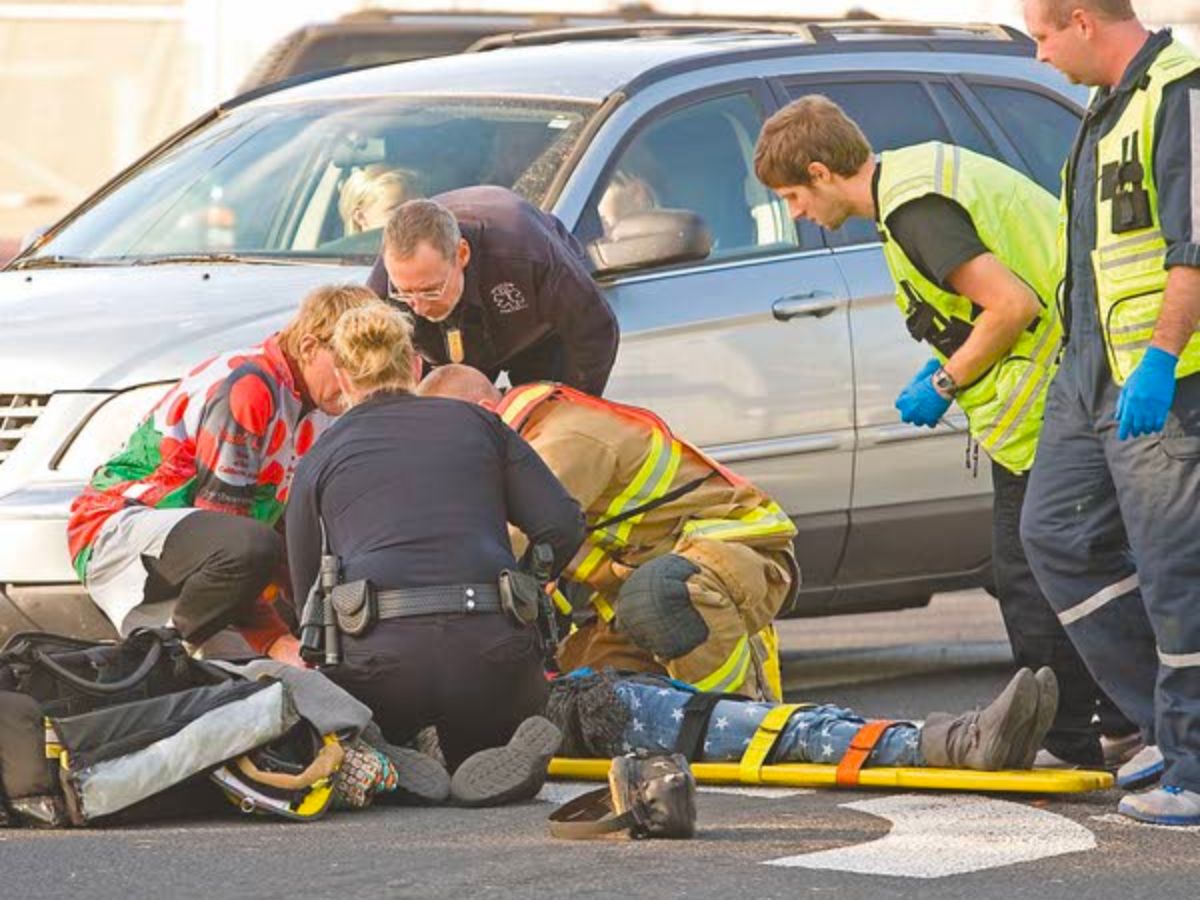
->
[755,95,1132,766]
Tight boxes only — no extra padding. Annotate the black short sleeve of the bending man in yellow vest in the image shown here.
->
[886,193,989,293]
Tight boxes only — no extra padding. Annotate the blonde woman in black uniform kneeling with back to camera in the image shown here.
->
[287,304,583,805]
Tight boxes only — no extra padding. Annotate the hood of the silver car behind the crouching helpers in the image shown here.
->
[0,263,368,394]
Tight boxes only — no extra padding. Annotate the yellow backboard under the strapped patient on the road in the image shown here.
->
[550,763,1112,793]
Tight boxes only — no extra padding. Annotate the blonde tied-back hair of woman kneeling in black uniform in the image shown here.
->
[330,302,421,409]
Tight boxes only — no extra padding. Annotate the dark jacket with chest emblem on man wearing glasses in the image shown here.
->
[367,185,619,396]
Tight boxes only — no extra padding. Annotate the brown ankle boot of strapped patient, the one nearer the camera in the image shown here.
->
[920,668,1040,772]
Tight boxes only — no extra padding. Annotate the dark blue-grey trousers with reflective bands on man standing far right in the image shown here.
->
[1021,335,1200,791]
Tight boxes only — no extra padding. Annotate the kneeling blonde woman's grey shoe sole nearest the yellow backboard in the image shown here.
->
[450,715,563,806]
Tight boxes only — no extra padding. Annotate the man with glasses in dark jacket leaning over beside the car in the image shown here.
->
[367,186,618,396]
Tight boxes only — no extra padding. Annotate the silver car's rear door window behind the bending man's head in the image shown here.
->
[786,80,950,247]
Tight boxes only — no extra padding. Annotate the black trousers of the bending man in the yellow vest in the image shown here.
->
[991,462,1118,768]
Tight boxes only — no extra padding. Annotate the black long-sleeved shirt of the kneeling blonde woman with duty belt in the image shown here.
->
[287,394,584,604]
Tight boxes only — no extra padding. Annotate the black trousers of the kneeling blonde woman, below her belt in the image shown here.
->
[325,613,548,770]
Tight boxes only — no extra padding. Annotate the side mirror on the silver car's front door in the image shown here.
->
[588,209,713,277]
